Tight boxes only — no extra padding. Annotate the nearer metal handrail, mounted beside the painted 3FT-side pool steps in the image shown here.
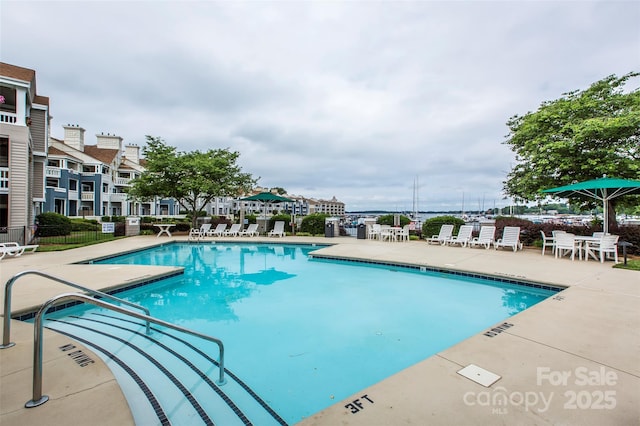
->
[25,293,225,408]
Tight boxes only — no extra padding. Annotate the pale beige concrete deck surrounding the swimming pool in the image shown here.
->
[0,236,640,426]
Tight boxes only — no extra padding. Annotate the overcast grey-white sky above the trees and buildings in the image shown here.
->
[0,0,640,211]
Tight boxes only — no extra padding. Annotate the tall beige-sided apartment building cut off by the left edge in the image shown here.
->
[0,62,51,242]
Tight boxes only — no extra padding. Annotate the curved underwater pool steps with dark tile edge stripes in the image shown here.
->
[45,313,286,426]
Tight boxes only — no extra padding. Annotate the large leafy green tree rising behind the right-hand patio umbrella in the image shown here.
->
[503,72,640,223]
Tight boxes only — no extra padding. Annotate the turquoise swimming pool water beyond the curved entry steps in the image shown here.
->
[48,243,554,424]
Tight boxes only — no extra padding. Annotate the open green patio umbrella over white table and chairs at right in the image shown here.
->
[542,177,640,232]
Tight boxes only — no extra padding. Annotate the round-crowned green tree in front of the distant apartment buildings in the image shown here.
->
[129,136,256,227]
